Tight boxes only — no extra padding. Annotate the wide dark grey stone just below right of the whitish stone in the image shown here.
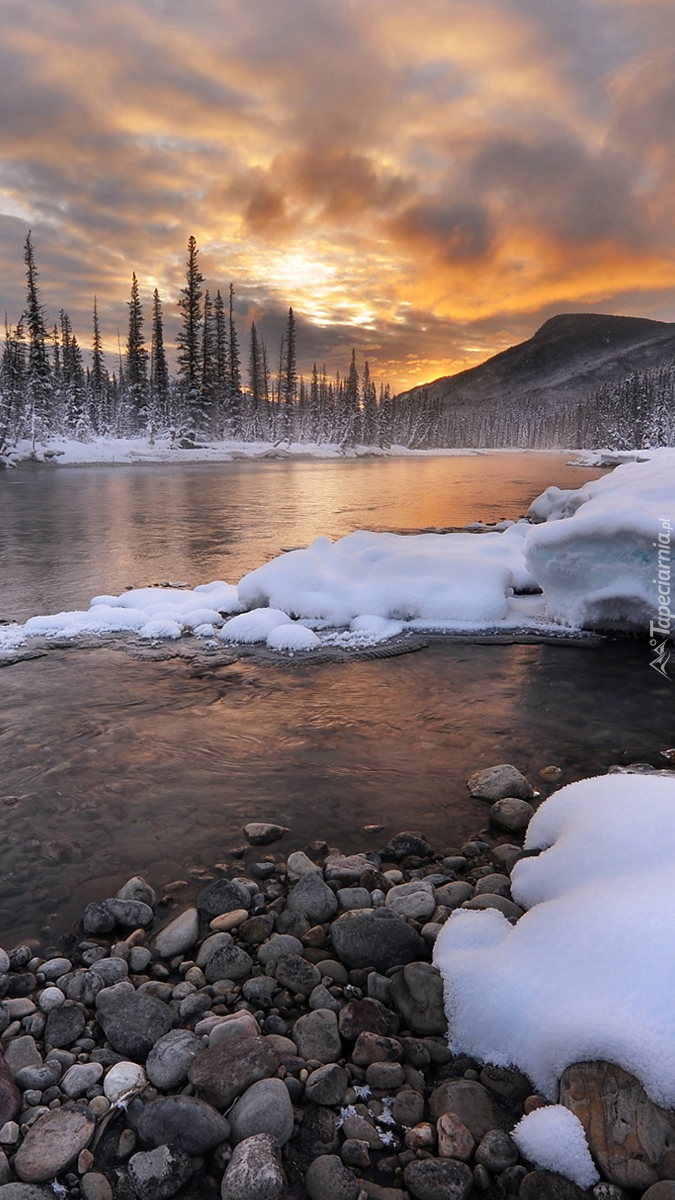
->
[137,1099,229,1156]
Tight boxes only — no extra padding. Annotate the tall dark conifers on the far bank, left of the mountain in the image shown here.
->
[0,233,410,454]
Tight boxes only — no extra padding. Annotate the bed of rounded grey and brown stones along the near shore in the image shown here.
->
[0,764,675,1200]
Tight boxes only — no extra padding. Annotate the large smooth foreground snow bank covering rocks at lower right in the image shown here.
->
[434,775,675,1108]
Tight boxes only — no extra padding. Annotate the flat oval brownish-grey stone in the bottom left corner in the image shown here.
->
[14,1109,96,1183]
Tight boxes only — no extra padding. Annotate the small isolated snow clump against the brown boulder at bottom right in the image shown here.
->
[512,1104,599,1188]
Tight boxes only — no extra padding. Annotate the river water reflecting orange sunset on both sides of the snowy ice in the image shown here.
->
[0,454,674,946]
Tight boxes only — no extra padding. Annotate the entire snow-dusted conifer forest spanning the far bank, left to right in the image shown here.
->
[0,233,675,456]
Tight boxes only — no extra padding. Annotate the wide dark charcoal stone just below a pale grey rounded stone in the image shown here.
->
[330,907,428,973]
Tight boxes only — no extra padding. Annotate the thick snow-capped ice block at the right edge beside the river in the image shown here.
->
[525,450,675,634]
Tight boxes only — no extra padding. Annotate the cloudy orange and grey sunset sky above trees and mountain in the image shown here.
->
[0,0,675,390]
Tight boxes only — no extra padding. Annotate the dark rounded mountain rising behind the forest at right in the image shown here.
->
[396,313,675,414]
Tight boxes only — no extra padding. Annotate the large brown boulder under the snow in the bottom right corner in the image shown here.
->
[560,1062,675,1190]
